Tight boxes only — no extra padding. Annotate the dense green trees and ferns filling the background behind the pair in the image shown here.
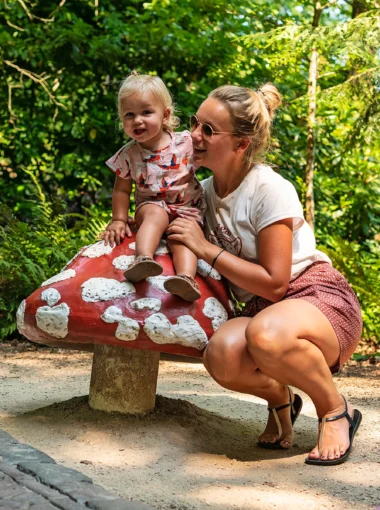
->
[0,0,380,338]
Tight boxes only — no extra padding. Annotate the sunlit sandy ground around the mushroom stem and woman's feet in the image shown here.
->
[0,344,380,510]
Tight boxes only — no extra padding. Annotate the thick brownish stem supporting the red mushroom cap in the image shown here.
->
[89,345,160,414]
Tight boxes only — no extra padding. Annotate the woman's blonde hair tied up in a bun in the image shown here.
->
[209,83,281,164]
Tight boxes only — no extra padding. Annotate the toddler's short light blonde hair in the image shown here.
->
[117,71,180,131]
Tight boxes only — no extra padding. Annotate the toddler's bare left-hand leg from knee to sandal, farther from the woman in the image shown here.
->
[136,204,169,258]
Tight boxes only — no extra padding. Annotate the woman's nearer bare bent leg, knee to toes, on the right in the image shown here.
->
[246,299,352,459]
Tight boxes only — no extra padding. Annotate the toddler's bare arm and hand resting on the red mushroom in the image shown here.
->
[99,176,132,246]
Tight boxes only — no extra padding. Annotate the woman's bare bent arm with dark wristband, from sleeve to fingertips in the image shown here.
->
[168,218,293,302]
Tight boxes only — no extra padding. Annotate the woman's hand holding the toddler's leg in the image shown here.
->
[166,218,210,258]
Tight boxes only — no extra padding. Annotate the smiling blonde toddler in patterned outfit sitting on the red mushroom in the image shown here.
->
[100,72,205,301]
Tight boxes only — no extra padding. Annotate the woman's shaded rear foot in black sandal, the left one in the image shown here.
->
[258,386,294,449]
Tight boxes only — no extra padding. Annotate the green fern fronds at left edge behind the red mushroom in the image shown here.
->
[0,175,106,338]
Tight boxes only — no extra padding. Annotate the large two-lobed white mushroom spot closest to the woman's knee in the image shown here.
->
[144,313,207,350]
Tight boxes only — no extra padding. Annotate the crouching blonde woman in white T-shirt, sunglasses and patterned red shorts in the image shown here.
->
[168,84,362,466]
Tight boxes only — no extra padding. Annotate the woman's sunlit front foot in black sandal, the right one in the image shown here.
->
[308,398,353,460]
